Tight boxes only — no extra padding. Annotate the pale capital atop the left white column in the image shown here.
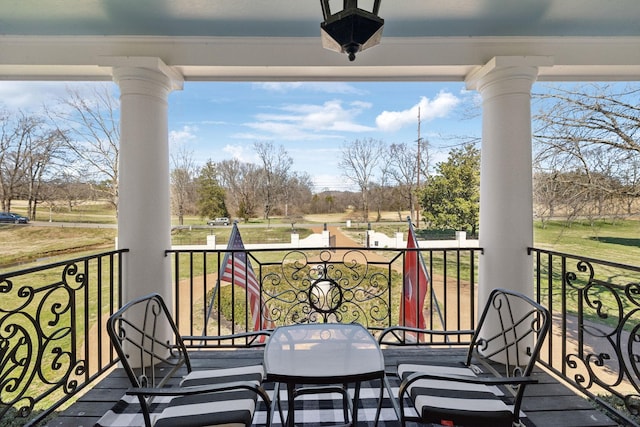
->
[99,56,184,91]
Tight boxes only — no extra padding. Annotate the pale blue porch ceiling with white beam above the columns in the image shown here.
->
[0,0,640,80]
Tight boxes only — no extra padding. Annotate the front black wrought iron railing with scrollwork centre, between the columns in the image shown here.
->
[167,247,481,342]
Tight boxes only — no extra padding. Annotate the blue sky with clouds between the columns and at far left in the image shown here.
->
[0,82,481,192]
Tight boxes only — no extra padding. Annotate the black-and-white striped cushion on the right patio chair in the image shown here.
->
[398,364,513,427]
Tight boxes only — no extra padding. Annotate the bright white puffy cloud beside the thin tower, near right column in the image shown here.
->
[376,92,460,131]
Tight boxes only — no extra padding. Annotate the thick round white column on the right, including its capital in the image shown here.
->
[467,57,551,307]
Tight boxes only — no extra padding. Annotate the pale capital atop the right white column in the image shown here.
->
[465,56,553,92]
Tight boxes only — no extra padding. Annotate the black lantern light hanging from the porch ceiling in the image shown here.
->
[320,0,384,61]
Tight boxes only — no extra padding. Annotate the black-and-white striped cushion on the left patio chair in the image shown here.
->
[154,365,264,427]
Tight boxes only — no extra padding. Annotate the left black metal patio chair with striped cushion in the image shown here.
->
[107,294,270,427]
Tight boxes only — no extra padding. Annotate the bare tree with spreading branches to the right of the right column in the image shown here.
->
[534,84,640,221]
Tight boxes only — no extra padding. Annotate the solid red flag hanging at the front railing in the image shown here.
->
[399,226,429,328]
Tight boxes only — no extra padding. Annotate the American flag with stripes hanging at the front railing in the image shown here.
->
[221,223,275,331]
